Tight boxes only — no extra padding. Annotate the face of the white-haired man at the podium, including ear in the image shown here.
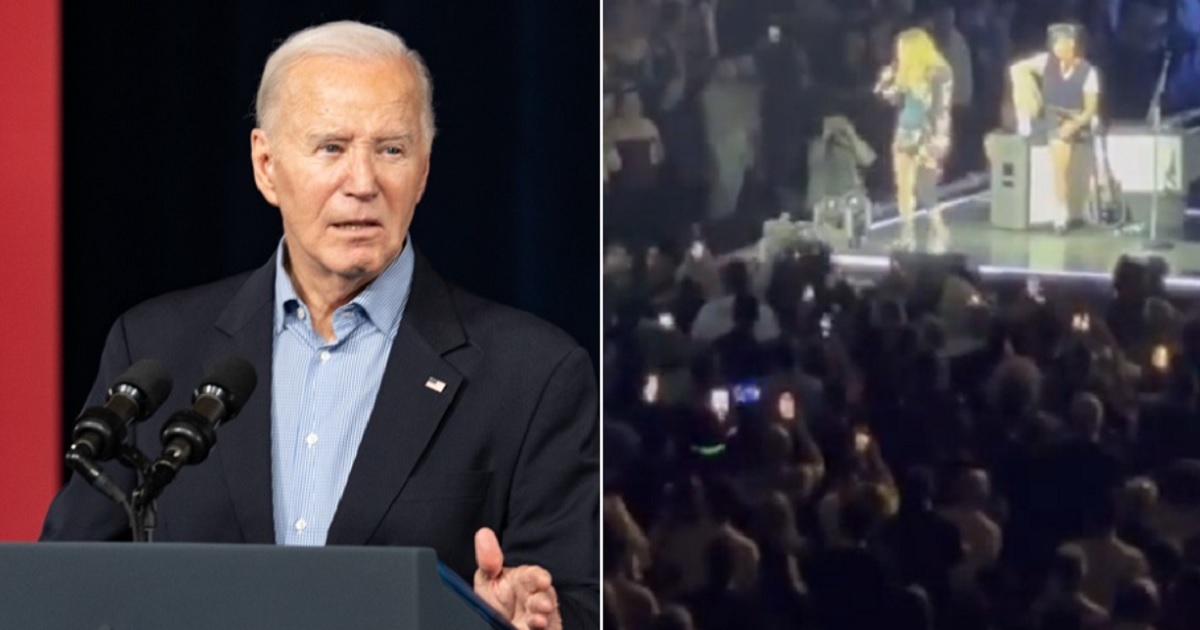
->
[251,56,430,281]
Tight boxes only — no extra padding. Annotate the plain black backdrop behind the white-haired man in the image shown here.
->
[62,0,600,451]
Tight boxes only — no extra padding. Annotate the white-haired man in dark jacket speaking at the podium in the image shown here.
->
[43,22,600,629]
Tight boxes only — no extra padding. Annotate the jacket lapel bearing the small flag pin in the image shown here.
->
[326,252,466,545]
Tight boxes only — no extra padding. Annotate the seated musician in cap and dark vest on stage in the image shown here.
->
[1009,24,1100,234]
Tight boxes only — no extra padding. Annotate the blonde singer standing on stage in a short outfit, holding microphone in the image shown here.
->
[875,29,954,253]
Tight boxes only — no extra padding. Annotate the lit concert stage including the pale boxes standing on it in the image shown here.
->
[836,110,1200,292]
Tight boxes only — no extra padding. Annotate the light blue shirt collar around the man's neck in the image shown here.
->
[275,236,416,337]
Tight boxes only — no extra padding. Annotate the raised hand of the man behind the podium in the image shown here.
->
[475,527,563,630]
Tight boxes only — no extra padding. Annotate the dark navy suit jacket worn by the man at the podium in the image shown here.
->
[42,248,600,628]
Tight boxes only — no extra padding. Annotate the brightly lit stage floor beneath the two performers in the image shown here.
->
[820,176,1200,293]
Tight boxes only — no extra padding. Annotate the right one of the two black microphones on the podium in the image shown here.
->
[136,356,258,505]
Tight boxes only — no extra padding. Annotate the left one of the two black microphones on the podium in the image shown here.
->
[67,359,172,462]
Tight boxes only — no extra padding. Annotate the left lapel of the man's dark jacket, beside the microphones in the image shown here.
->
[215,257,275,545]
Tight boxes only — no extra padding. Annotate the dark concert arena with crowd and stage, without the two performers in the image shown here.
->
[604,0,1200,630]
